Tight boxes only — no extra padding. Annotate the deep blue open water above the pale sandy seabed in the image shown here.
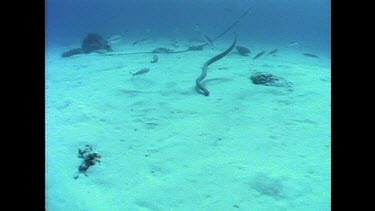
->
[47,0,331,51]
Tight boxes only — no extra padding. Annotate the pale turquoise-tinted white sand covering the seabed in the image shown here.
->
[47,38,331,211]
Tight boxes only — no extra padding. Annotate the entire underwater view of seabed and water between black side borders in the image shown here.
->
[45,0,331,211]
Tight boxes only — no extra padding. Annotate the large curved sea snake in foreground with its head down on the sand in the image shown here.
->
[195,33,237,96]
